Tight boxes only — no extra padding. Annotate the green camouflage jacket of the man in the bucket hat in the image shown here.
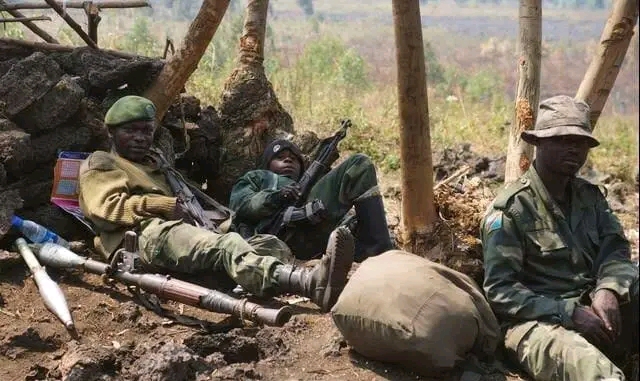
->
[481,166,638,328]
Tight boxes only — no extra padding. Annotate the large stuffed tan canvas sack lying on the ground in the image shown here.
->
[331,250,500,376]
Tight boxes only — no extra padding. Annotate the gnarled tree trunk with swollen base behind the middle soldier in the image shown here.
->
[212,0,293,200]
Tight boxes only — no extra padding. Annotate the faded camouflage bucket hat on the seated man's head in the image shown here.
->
[520,95,600,148]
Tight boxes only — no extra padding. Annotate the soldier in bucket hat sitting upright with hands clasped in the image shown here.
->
[481,95,639,381]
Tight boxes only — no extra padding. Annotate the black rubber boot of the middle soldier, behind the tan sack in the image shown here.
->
[354,196,394,262]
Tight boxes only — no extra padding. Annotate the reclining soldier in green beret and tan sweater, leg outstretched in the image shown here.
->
[79,96,354,311]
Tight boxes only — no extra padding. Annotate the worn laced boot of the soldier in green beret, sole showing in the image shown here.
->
[277,227,354,312]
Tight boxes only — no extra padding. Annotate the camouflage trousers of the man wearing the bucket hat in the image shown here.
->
[505,279,639,381]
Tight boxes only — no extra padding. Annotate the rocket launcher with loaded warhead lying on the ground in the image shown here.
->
[36,231,291,327]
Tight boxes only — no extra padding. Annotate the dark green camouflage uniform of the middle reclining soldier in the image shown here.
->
[229,154,386,259]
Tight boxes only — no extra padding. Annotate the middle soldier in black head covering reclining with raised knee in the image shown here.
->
[229,139,393,262]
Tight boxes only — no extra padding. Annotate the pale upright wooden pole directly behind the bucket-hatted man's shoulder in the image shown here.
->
[504,0,542,183]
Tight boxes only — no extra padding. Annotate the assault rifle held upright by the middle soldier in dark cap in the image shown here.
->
[261,119,351,235]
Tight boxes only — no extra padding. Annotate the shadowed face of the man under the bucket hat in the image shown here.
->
[536,135,591,176]
